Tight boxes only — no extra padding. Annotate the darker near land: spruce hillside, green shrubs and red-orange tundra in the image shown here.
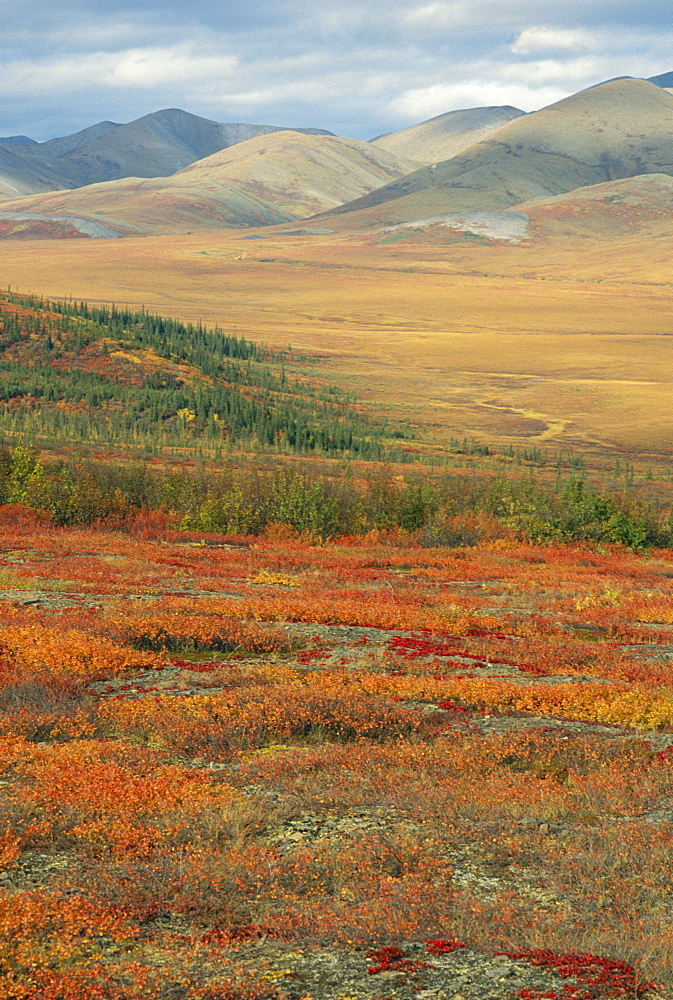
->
[0,295,673,1000]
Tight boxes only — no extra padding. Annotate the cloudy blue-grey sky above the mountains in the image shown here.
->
[0,0,673,141]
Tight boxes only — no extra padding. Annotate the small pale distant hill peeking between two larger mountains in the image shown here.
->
[371,105,525,163]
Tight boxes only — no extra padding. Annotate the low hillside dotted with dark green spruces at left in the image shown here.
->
[0,292,401,457]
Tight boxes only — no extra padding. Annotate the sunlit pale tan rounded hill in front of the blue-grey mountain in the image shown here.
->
[0,131,417,235]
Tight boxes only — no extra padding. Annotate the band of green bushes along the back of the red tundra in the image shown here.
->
[0,444,673,548]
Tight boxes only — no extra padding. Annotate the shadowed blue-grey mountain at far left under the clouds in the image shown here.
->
[0,108,332,196]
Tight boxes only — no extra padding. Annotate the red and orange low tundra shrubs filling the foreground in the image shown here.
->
[0,504,673,1000]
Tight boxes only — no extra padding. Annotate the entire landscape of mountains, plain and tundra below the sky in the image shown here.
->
[0,66,673,1000]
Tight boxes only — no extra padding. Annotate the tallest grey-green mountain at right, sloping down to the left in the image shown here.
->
[318,79,673,226]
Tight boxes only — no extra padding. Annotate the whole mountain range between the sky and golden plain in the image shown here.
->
[0,73,673,238]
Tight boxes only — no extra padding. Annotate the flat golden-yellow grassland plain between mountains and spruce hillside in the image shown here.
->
[0,227,673,456]
